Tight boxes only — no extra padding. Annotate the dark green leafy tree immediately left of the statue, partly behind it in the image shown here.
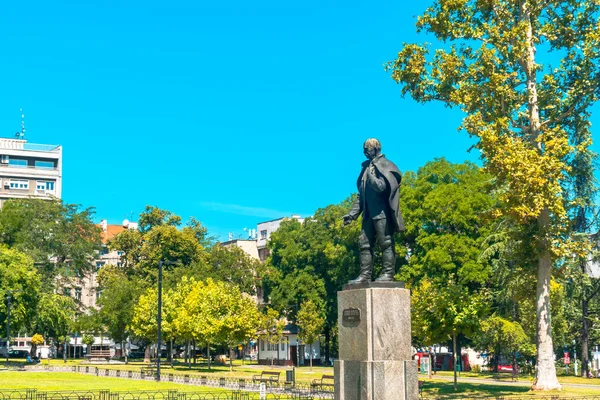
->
[262,205,356,359]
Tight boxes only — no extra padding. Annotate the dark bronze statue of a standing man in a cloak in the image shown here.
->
[344,139,404,285]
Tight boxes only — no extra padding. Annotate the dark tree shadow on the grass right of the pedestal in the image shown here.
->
[422,381,531,399]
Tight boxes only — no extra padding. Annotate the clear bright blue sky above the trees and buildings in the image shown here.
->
[0,0,596,238]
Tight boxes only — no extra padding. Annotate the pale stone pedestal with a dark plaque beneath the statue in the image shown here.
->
[334,282,419,400]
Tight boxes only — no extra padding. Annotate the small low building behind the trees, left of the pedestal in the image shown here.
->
[258,324,321,366]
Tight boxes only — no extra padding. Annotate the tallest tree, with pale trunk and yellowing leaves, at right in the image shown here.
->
[389,0,600,390]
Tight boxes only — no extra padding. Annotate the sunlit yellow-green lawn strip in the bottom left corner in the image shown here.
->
[0,371,222,392]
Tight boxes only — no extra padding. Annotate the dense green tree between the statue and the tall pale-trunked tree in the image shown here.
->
[399,159,494,385]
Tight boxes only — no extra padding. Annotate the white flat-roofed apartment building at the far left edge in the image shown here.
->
[0,138,62,207]
